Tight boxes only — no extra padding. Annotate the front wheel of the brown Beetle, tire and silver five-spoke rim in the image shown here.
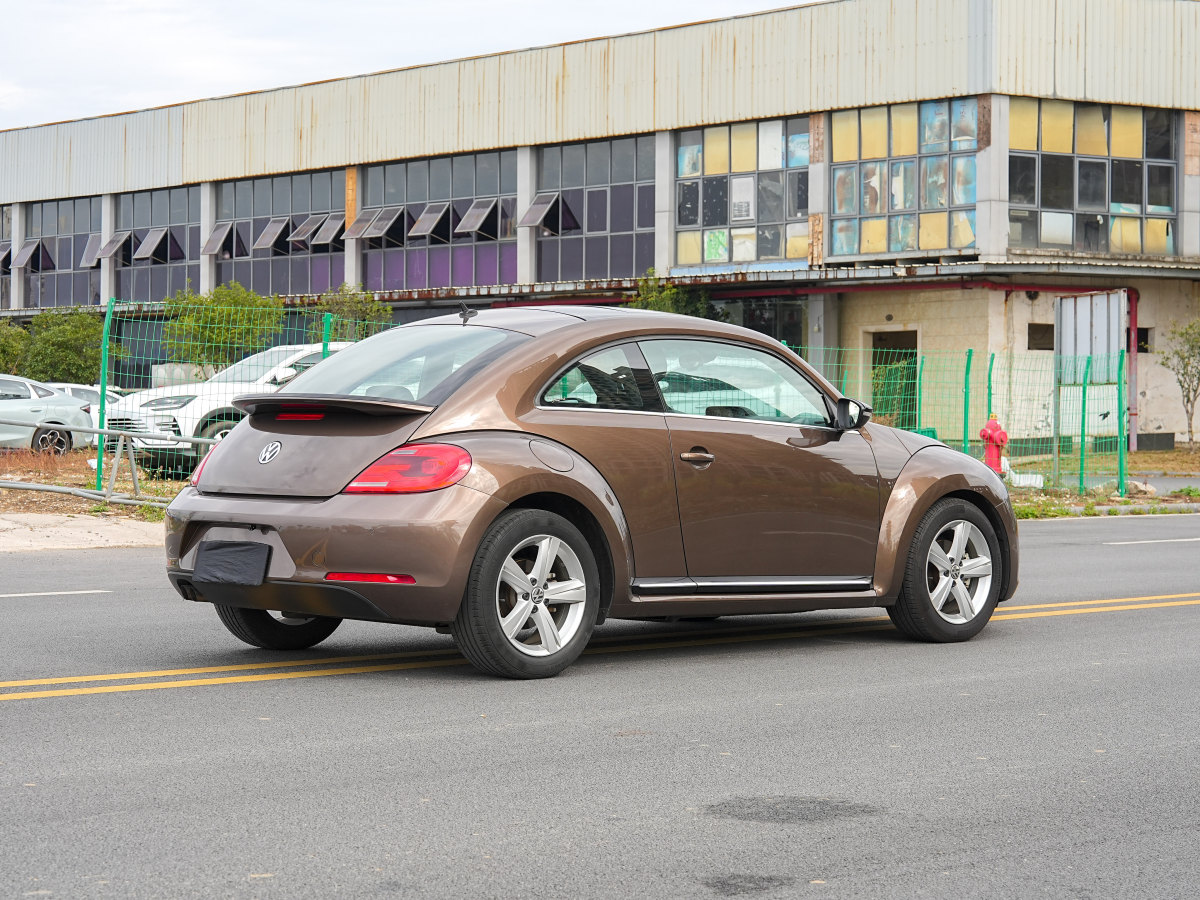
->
[888,497,1001,643]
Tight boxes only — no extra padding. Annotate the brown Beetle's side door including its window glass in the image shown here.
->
[640,338,880,592]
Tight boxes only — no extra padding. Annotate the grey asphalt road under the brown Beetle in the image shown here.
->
[0,516,1200,898]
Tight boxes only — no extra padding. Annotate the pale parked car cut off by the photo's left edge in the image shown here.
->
[0,376,98,454]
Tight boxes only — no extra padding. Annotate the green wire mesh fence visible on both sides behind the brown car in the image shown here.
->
[96,301,1126,493]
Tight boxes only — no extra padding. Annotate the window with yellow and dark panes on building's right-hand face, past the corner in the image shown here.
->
[1008,97,1176,256]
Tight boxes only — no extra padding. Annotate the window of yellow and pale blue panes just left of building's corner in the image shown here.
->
[829,97,979,256]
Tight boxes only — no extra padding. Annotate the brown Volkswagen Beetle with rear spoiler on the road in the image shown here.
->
[167,306,1018,678]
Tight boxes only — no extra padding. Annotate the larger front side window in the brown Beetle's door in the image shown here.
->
[638,340,829,425]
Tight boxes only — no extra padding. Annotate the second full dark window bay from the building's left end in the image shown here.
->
[114,186,200,302]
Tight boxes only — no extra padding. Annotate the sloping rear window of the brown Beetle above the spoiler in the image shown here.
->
[281,325,529,406]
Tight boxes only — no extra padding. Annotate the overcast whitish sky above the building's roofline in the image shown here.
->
[0,0,812,128]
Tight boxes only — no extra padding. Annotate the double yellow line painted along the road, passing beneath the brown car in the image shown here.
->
[0,593,1200,701]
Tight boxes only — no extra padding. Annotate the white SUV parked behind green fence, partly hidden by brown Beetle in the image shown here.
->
[106,342,350,469]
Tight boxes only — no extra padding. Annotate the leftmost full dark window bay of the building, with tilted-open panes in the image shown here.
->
[21,197,100,307]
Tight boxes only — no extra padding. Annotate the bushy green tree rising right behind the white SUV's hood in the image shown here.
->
[162,281,283,368]
